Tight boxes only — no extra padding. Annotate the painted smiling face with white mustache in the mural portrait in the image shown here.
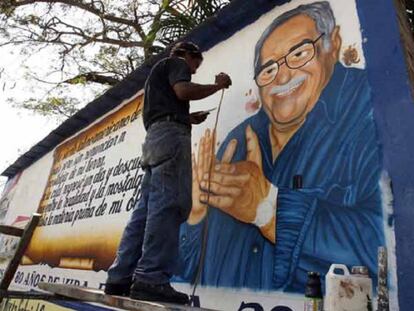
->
[259,15,341,131]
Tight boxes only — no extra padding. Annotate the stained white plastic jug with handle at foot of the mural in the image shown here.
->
[324,264,372,311]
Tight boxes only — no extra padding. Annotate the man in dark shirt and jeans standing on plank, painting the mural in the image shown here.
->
[105,42,231,304]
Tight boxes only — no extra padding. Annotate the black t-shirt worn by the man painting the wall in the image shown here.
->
[144,57,191,129]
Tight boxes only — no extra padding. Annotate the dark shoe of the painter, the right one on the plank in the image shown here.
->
[129,281,189,305]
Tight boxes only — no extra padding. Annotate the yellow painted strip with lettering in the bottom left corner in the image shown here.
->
[0,299,73,311]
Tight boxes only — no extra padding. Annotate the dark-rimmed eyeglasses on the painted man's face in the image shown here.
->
[254,33,325,87]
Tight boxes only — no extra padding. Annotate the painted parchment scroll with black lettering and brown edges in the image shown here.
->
[25,96,143,271]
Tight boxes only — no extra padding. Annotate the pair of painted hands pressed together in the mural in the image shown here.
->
[189,126,275,241]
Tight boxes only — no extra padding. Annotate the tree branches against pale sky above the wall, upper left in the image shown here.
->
[0,0,230,117]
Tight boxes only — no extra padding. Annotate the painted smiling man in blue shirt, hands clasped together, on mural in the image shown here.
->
[180,2,384,292]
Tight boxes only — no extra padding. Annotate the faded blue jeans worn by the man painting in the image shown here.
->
[107,121,192,284]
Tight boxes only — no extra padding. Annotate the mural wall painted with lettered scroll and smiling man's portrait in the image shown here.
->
[0,0,413,310]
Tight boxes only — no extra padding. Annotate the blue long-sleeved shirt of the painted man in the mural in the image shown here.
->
[179,64,384,292]
